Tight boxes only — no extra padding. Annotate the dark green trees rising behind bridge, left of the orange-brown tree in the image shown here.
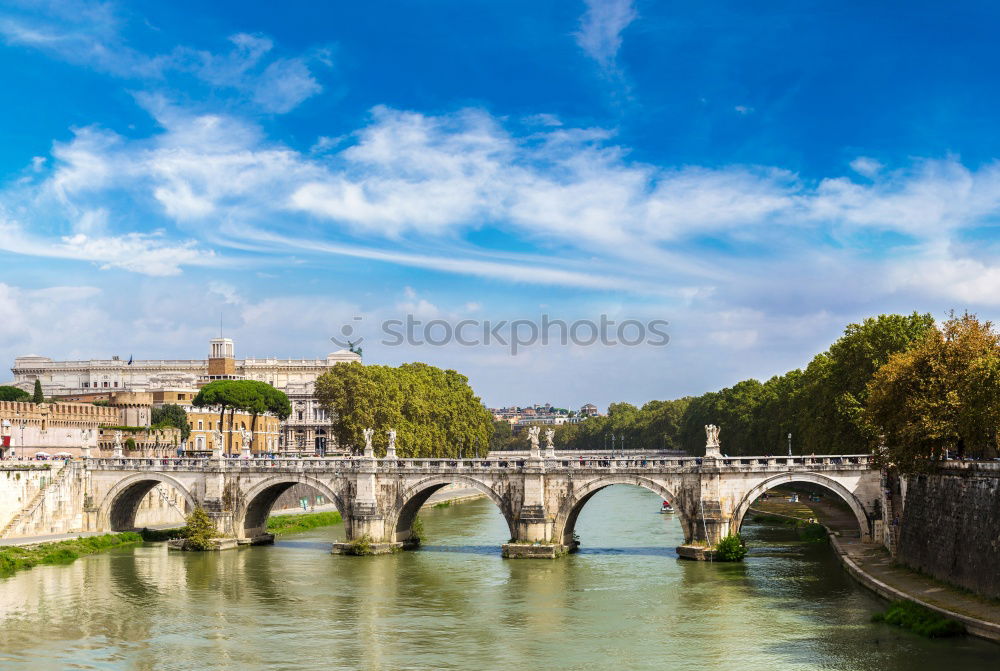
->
[556,313,934,455]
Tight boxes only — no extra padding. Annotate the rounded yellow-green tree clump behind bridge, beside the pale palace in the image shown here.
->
[316,362,493,458]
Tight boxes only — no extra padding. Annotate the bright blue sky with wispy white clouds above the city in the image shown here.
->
[0,0,1000,406]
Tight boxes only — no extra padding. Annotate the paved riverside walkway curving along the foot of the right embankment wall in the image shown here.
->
[752,495,1000,643]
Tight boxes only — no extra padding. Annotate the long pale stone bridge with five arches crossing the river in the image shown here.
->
[84,451,881,556]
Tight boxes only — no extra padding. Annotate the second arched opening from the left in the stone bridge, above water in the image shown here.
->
[237,476,343,540]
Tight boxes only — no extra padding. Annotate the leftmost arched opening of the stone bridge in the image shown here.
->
[102,474,195,531]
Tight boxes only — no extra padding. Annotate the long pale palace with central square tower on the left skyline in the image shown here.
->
[11,338,361,453]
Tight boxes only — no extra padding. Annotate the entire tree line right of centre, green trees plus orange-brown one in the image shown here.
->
[548,312,1000,470]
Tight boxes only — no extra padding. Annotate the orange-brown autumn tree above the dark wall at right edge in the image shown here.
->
[863,313,1000,473]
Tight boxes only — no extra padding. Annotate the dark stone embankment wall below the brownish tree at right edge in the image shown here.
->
[896,462,1000,598]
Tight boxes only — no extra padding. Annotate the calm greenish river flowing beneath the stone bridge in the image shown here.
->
[0,486,1000,671]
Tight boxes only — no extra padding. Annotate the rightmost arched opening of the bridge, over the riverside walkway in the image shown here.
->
[732,473,872,540]
